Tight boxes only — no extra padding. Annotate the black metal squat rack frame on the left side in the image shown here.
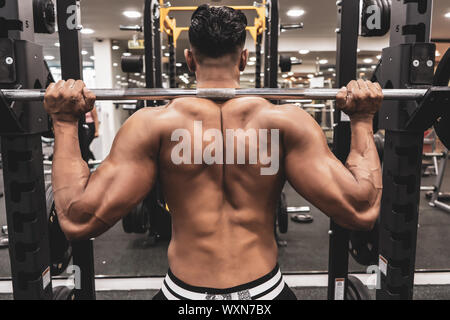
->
[0,0,95,300]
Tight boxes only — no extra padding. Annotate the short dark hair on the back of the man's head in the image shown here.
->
[189,4,247,58]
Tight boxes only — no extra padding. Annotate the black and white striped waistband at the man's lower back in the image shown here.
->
[162,265,285,300]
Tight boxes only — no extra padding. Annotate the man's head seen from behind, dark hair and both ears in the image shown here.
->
[185,4,248,71]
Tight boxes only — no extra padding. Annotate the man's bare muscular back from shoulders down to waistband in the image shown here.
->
[155,98,284,288]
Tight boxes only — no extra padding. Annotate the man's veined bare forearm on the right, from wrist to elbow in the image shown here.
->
[346,118,382,212]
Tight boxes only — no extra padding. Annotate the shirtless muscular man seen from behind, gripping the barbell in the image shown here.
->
[45,5,383,299]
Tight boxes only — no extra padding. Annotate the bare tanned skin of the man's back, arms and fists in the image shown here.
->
[45,77,381,288]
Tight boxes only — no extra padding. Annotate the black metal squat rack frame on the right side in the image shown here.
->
[328,0,450,300]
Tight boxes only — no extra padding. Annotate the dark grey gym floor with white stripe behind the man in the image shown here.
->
[0,159,450,300]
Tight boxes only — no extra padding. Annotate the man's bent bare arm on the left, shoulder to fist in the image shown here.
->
[45,80,159,240]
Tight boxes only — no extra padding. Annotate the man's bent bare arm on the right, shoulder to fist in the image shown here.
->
[284,82,382,230]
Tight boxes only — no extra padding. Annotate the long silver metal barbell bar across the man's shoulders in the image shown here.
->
[0,87,440,101]
